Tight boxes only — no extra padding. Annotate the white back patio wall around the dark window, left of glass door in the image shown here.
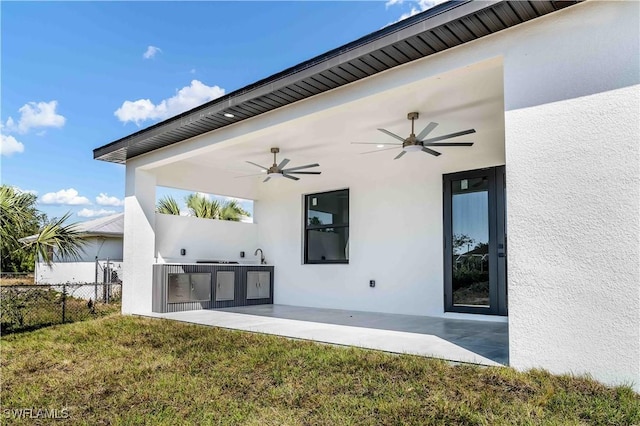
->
[254,146,504,316]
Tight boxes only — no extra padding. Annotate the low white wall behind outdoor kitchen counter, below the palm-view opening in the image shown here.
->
[155,214,258,263]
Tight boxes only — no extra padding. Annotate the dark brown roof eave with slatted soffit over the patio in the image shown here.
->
[93,0,581,163]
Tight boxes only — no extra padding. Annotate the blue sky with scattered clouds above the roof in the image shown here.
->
[0,0,440,221]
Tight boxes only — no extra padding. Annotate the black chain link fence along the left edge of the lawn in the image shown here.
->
[0,282,122,334]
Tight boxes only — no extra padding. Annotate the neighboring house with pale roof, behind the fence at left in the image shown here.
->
[22,213,124,284]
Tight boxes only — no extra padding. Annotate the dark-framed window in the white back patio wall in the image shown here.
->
[304,189,349,263]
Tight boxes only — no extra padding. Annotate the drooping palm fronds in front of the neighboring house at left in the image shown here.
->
[24,212,86,266]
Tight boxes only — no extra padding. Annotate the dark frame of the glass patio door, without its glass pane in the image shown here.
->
[442,166,507,315]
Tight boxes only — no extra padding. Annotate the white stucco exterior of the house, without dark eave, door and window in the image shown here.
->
[117,1,640,390]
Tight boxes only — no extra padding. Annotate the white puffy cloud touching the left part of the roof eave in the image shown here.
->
[114,80,224,126]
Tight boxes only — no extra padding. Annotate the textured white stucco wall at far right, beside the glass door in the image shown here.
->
[504,2,640,390]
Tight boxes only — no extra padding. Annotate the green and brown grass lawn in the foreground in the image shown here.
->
[0,315,640,425]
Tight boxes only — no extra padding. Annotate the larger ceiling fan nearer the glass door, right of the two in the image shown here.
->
[351,112,476,160]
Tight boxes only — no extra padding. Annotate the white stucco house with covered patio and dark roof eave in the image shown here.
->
[94,1,640,390]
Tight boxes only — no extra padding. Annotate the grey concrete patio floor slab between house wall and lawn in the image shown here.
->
[147,305,509,366]
